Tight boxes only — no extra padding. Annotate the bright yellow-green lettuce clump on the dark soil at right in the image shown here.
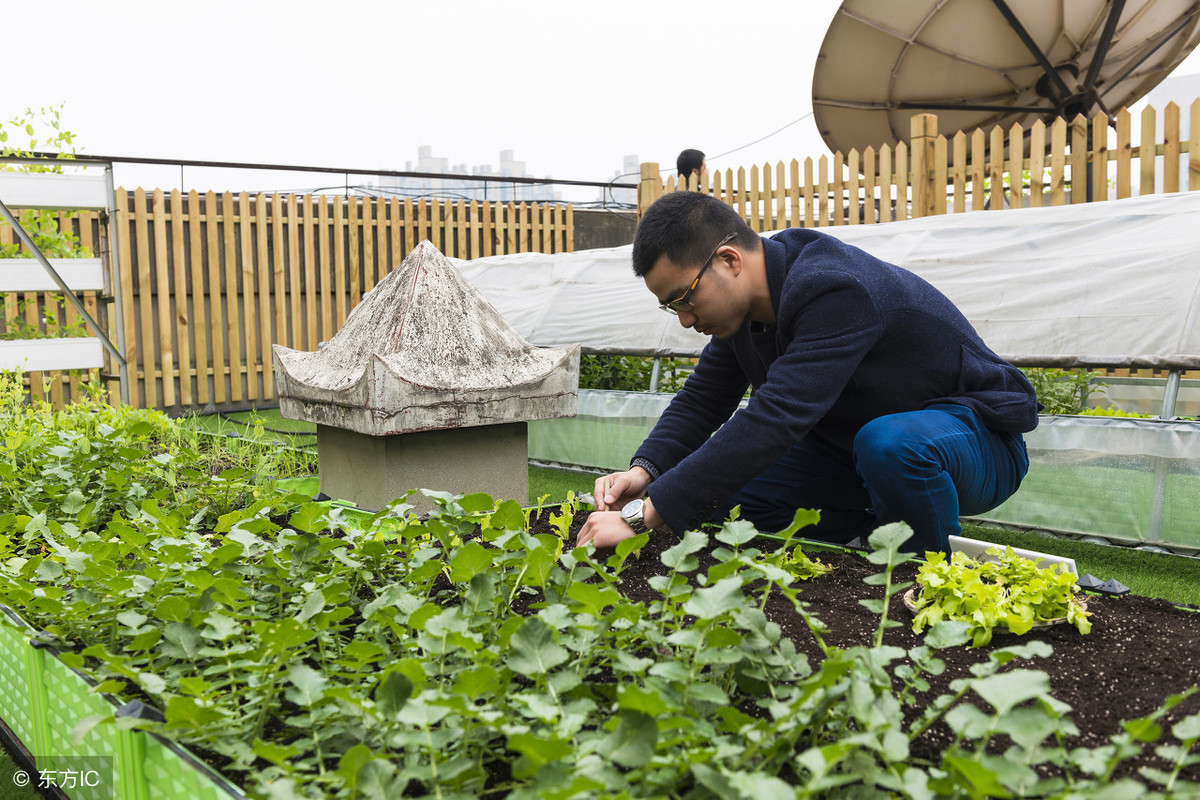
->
[912,547,1092,648]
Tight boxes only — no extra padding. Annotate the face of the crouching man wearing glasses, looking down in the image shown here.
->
[643,246,746,339]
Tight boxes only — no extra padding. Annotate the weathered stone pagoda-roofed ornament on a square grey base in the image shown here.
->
[274,241,580,511]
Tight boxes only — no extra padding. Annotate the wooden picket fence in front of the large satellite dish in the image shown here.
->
[638,100,1200,231]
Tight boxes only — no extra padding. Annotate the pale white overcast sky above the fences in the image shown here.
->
[9,0,1200,197]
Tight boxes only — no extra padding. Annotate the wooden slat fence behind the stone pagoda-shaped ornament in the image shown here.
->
[0,188,574,411]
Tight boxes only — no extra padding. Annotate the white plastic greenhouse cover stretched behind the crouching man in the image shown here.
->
[455,192,1200,368]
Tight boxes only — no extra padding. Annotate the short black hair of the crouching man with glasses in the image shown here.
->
[634,192,762,278]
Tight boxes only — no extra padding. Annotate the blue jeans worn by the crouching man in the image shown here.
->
[724,403,1030,553]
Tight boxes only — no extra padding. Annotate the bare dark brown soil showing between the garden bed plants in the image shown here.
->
[542,512,1200,781]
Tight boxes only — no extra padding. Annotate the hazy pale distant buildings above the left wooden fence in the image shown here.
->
[365,145,562,203]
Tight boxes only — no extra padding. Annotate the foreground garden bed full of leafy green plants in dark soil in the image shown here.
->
[0,383,1200,800]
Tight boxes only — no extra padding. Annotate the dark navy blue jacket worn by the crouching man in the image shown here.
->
[635,229,1038,533]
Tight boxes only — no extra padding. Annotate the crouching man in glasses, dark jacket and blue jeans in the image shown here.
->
[578,192,1038,552]
